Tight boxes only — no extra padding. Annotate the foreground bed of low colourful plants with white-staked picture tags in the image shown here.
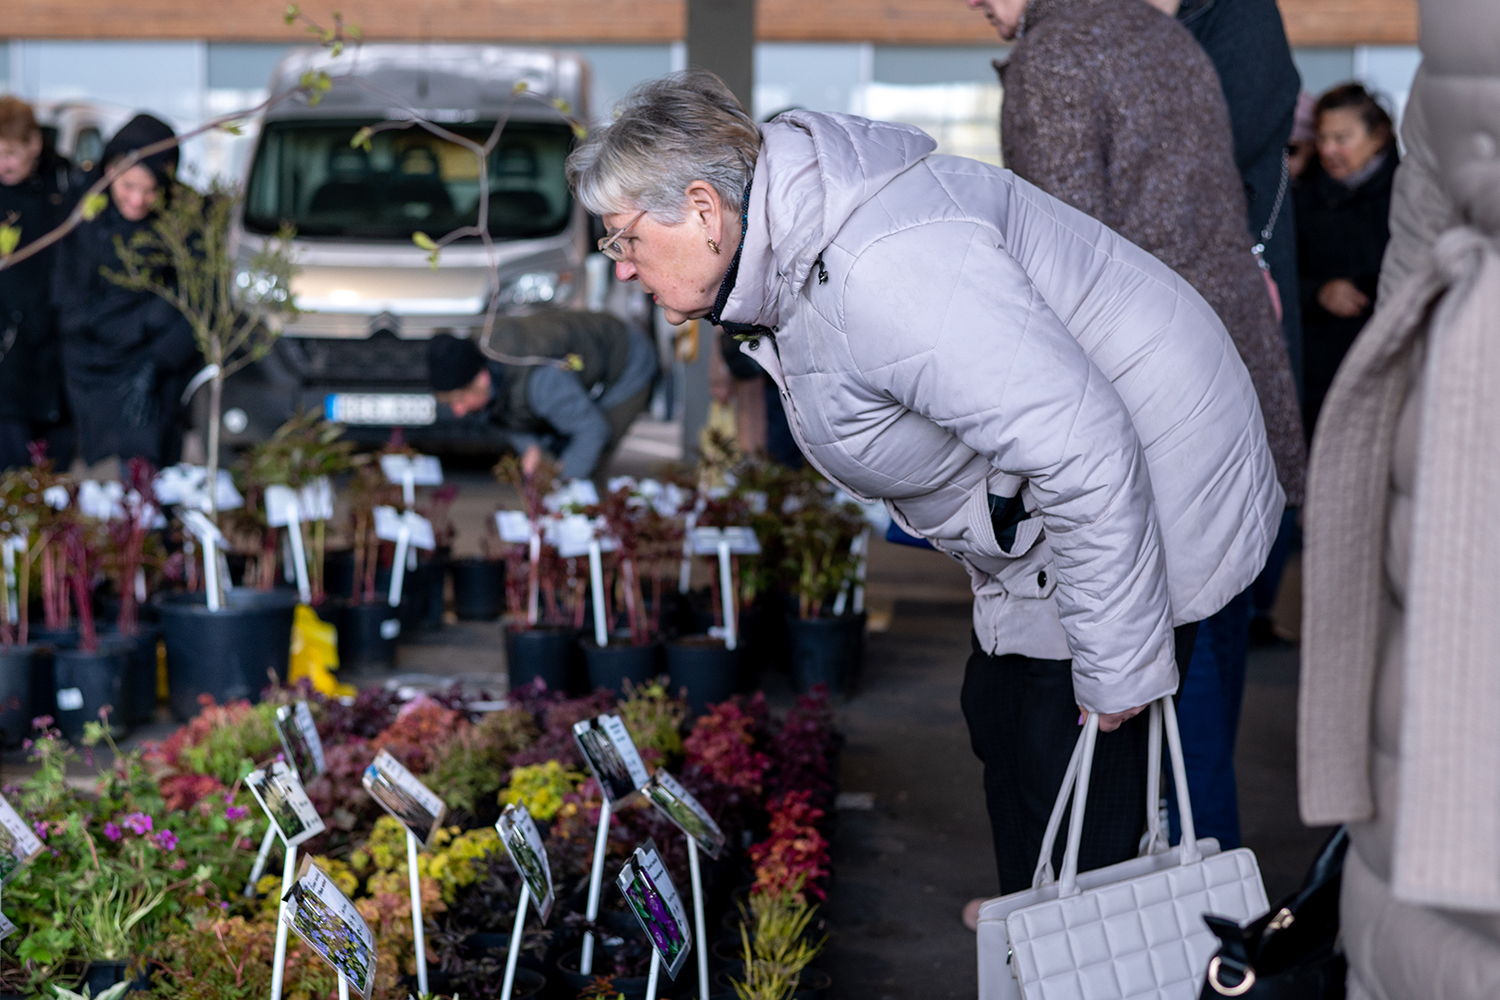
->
[0,671,837,1000]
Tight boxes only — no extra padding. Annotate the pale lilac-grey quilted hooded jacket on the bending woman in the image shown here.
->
[722,111,1283,712]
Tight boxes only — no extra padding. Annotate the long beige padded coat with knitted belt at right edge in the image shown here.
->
[1299,0,1500,1000]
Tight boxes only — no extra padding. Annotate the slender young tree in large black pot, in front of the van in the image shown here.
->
[107,183,296,720]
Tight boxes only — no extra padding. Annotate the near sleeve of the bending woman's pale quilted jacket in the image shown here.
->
[843,222,1178,712]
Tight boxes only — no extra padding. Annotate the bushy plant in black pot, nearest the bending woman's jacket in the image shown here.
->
[782,486,866,694]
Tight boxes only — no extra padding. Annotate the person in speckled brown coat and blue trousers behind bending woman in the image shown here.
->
[968,0,1307,917]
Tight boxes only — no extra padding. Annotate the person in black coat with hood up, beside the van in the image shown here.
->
[53,114,201,466]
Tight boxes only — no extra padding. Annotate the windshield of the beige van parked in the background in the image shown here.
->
[245,120,573,241]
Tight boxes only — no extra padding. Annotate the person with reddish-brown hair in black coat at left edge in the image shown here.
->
[0,97,72,469]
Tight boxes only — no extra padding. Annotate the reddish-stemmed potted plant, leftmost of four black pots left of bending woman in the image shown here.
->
[495,456,588,691]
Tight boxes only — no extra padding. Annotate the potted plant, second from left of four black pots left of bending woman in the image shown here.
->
[582,483,683,693]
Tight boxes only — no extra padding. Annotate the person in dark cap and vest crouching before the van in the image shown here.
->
[428,312,657,480]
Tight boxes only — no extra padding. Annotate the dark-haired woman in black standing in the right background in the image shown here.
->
[1296,84,1398,441]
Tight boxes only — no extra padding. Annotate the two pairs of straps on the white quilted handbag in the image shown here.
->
[1032,694,1203,897]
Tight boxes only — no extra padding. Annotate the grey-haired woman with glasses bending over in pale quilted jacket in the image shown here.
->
[569,72,1283,892]
